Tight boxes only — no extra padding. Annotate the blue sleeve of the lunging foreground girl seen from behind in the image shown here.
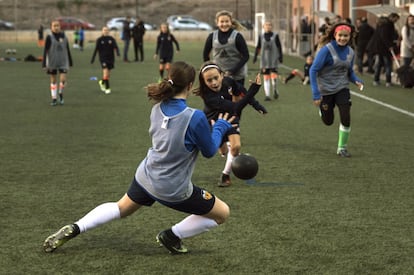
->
[185,110,232,158]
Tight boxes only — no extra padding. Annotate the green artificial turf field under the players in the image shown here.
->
[0,42,414,274]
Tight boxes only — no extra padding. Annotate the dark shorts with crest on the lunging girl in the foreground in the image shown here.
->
[127,177,216,215]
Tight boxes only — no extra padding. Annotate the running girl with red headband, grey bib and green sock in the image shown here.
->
[310,23,363,157]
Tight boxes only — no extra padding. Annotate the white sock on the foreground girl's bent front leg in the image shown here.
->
[171,215,218,239]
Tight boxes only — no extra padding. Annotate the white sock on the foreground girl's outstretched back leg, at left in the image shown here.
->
[75,202,121,232]
